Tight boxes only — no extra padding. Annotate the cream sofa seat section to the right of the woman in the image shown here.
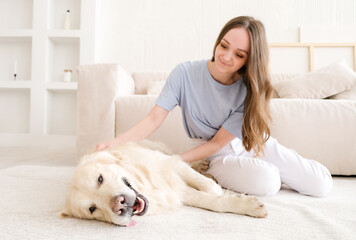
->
[271,99,356,175]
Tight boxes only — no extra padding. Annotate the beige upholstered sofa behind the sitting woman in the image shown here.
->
[77,64,356,175]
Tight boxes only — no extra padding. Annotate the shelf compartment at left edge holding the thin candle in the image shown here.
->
[0,37,32,81]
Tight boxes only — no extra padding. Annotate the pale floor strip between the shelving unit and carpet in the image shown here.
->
[0,147,78,169]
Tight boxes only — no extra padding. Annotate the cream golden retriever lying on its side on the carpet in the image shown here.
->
[61,142,267,226]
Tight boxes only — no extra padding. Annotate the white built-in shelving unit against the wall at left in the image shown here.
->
[0,0,97,146]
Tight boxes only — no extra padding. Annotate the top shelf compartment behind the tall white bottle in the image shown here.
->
[48,0,81,29]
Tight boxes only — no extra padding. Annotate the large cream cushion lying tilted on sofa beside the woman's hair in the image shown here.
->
[274,61,356,99]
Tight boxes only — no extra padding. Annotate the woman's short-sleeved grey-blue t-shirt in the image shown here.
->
[156,60,246,140]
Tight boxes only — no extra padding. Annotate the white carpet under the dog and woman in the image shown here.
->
[0,165,356,240]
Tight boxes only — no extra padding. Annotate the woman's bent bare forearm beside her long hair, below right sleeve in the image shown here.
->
[180,128,235,162]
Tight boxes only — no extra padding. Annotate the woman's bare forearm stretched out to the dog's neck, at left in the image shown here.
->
[96,105,169,151]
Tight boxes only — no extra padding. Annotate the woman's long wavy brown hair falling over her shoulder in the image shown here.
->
[211,16,272,156]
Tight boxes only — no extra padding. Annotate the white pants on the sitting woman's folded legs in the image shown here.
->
[191,137,333,197]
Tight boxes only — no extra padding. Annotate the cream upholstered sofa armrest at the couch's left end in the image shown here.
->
[76,64,135,157]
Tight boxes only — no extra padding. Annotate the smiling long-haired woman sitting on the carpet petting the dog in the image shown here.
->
[97,16,333,197]
